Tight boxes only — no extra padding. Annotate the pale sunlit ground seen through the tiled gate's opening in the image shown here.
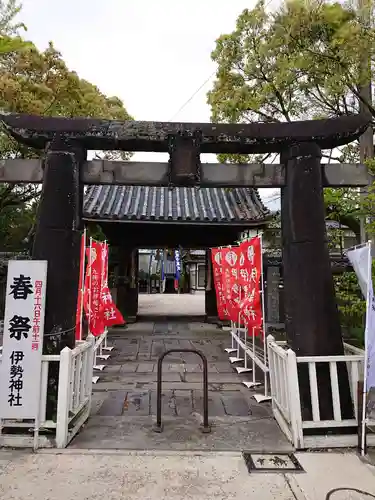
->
[138,291,205,316]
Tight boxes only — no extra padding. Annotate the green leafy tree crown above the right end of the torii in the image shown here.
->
[208,0,375,161]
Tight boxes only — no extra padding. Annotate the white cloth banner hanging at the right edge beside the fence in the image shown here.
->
[347,242,375,391]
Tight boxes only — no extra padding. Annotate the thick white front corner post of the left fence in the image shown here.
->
[56,347,72,448]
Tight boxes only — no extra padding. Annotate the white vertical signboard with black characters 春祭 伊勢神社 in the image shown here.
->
[0,260,47,419]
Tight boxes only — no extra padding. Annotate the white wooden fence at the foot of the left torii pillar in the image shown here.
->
[0,338,94,449]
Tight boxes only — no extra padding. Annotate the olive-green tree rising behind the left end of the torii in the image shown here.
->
[0,0,132,250]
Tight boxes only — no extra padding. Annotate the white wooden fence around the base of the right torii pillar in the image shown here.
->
[267,336,375,449]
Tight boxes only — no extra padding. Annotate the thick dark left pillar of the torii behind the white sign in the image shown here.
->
[32,136,86,354]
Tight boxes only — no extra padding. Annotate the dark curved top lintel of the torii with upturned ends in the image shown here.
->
[0,114,369,154]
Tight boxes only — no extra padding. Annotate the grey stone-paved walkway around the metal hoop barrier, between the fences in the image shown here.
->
[70,321,291,452]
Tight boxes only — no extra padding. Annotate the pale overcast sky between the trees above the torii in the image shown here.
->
[21,0,275,209]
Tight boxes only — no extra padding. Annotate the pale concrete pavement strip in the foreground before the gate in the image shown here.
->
[0,450,375,500]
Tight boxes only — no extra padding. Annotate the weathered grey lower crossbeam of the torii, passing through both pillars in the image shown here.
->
[0,160,368,188]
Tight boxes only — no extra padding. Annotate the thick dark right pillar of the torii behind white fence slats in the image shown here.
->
[281,143,353,419]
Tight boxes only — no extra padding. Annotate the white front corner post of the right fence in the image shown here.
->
[286,349,303,449]
